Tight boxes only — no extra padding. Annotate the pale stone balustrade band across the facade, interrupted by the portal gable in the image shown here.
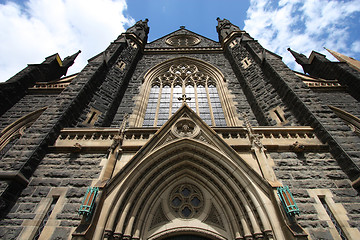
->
[50,126,328,152]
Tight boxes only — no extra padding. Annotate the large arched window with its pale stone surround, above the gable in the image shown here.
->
[134,58,237,127]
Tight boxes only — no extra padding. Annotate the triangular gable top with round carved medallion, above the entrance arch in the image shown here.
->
[107,104,270,192]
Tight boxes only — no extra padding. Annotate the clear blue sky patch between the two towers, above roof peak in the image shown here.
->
[127,0,250,42]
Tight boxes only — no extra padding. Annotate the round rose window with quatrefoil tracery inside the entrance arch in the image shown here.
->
[170,184,204,218]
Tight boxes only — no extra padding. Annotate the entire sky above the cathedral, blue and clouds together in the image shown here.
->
[0,0,360,82]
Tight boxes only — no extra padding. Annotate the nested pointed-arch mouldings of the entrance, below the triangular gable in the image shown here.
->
[95,138,284,239]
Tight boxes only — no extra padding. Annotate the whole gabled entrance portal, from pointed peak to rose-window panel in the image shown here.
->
[89,104,290,239]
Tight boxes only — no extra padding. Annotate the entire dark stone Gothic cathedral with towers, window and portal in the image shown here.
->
[0,18,360,240]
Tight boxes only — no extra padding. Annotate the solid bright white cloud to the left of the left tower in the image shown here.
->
[0,0,135,81]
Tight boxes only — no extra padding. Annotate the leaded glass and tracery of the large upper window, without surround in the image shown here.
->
[143,63,226,127]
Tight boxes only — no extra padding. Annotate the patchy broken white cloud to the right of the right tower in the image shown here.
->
[244,0,360,71]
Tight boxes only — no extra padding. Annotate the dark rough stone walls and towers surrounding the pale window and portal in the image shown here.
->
[0,19,360,239]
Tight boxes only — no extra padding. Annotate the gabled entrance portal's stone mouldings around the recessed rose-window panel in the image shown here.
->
[89,104,292,239]
